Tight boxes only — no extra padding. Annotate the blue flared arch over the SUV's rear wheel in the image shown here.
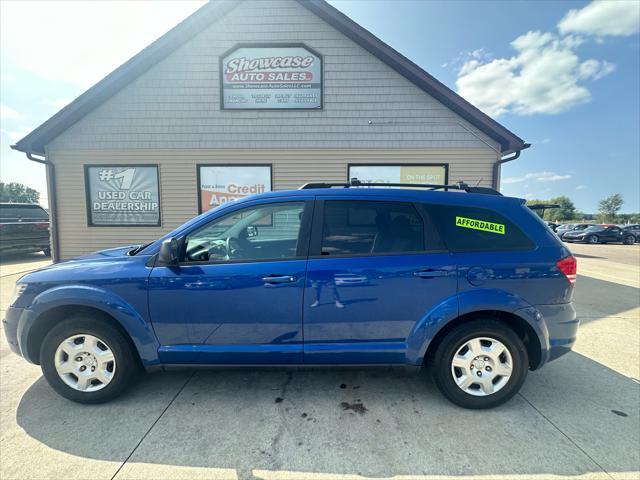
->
[407,289,549,365]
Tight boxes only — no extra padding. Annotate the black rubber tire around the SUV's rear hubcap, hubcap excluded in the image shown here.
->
[431,319,529,409]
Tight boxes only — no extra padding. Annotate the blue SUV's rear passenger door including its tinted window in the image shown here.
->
[303,196,457,364]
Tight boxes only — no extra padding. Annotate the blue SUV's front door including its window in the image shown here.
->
[149,197,313,364]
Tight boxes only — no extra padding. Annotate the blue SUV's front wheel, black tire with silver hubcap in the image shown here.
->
[40,316,141,403]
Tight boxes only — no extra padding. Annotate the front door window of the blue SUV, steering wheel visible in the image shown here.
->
[183,202,305,262]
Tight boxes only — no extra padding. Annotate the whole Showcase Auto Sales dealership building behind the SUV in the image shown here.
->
[13,0,528,260]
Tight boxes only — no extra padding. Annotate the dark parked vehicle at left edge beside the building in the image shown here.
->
[0,203,51,256]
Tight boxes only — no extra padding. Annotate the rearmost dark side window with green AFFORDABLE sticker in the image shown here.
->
[427,205,535,252]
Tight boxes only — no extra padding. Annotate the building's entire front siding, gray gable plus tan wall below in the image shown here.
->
[46,0,499,259]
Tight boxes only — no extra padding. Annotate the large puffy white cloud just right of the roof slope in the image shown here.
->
[456,31,615,117]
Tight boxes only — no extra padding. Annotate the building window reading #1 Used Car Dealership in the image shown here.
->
[84,165,160,227]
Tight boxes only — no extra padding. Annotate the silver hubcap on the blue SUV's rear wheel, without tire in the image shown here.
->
[451,337,513,397]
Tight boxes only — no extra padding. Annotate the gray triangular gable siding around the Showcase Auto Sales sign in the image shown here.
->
[48,0,498,151]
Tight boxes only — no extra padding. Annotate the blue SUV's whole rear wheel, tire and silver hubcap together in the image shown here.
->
[432,319,529,409]
